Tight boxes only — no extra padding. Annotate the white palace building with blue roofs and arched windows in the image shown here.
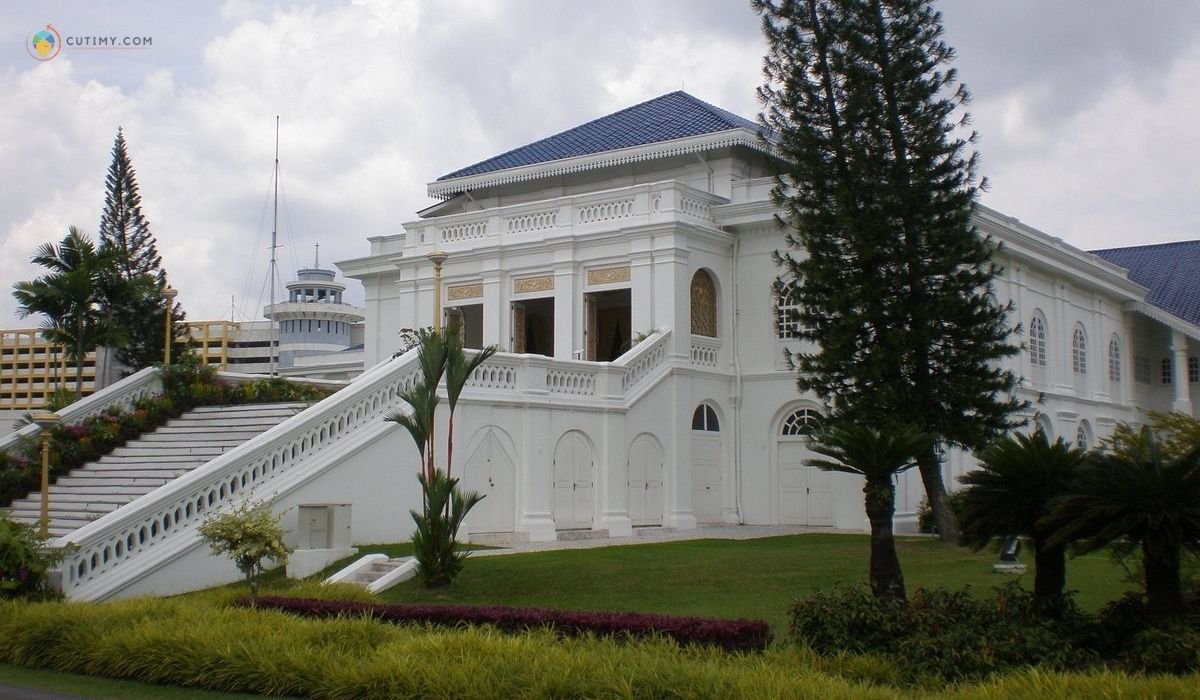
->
[11,92,1200,599]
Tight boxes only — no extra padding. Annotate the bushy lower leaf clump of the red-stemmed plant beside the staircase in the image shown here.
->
[410,467,484,588]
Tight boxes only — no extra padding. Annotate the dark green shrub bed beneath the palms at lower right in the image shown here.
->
[788,584,1200,682]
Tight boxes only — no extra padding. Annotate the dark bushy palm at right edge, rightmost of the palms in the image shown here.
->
[1045,427,1200,616]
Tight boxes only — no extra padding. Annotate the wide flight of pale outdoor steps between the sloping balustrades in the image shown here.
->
[8,403,306,537]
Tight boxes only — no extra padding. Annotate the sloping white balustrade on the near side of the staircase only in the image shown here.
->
[58,348,420,597]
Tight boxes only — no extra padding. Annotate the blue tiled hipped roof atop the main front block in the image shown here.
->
[438,90,760,180]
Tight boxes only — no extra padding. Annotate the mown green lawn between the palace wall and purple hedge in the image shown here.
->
[382,534,1130,635]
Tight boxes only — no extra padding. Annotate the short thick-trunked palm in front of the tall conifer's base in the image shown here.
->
[805,424,932,600]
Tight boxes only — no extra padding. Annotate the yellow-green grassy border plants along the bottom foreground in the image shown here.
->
[0,594,1200,700]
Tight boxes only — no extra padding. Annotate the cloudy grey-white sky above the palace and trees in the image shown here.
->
[0,0,1200,328]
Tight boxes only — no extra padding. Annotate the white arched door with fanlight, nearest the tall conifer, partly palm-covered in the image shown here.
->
[775,408,834,527]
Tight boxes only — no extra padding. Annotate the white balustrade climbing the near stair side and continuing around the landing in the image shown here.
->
[60,331,668,598]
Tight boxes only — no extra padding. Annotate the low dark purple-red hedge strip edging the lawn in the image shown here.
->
[238,597,770,652]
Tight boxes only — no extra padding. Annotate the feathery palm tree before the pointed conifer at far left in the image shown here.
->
[12,226,125,399]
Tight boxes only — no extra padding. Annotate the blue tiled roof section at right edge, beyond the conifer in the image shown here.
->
[1092,240,1200,325]
